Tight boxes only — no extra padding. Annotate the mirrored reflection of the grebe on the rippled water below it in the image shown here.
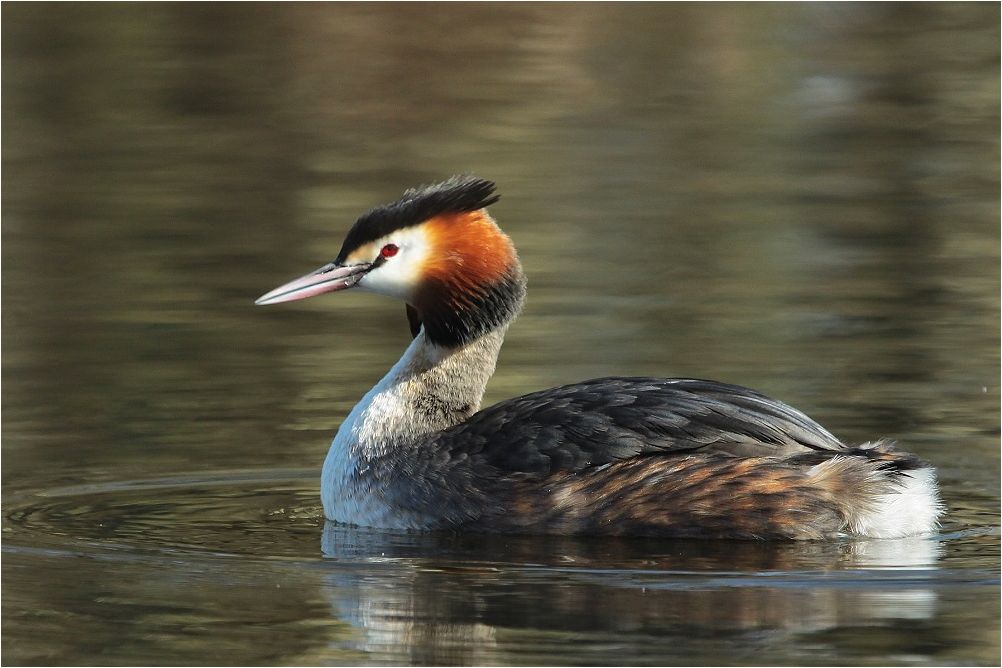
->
[323,522,943,664]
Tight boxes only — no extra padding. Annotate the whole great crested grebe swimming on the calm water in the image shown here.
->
[257,176,943,539]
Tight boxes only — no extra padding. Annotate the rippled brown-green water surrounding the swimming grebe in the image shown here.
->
[2,3,1000,665]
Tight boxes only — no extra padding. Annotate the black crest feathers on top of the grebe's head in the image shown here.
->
[335,176,500,263]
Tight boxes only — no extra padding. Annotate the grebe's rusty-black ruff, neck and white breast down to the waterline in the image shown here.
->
[321,211,525,527]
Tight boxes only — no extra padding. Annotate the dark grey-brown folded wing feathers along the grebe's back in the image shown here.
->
[422,378,846,478]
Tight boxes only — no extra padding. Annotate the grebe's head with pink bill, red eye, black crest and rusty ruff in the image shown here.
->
[256,176,525,348]
